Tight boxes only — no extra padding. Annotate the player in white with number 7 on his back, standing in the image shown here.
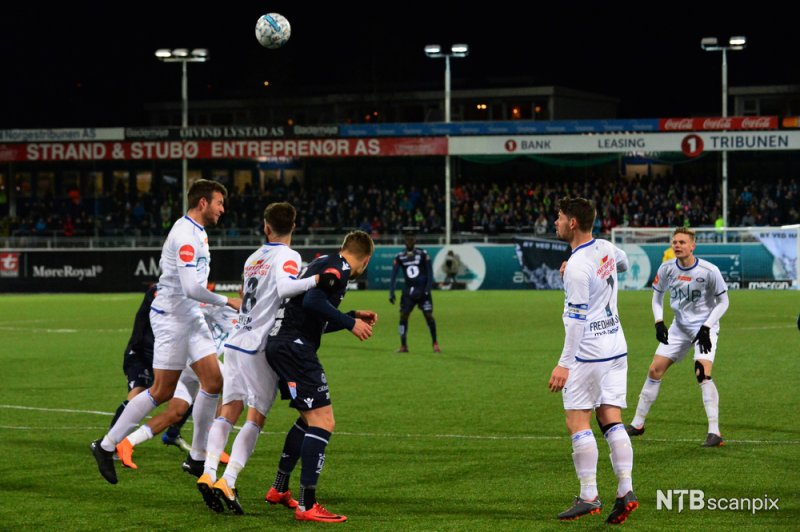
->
[548,198,639,524]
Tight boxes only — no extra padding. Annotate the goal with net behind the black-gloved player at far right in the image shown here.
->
[611,225,800,289]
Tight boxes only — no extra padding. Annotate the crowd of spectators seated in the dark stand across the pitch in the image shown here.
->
[0,172,800,236]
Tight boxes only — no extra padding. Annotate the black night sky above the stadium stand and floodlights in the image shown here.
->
[0,1,800,129]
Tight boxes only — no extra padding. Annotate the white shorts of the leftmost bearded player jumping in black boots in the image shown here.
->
[150,307,217,370]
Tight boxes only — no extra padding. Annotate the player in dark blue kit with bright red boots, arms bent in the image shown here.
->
[266,231,378,523]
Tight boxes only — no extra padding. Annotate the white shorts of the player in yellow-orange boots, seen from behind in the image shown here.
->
[222,346,278,416]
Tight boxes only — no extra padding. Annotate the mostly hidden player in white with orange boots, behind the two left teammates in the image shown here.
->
[117,304,239,477]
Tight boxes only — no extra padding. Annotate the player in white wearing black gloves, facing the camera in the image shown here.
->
[626,227,728,447]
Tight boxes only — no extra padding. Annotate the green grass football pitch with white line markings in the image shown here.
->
[0,291,800,531]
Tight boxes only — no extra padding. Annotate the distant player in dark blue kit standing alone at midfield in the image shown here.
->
[389,233,441,353]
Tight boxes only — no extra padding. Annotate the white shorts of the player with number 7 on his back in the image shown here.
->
[561,355,628,410]
